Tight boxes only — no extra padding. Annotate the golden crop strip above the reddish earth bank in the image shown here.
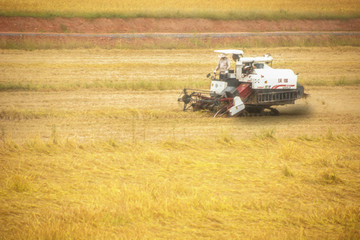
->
[0,0,360,19]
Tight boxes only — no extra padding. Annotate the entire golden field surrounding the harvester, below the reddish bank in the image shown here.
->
[0,47,360,239]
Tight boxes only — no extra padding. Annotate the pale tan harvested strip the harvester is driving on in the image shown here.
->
[0,87,360,141]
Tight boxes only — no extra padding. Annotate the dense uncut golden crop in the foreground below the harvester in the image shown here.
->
[0,134,360,239]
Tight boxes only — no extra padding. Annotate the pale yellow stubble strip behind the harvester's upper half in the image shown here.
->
[0,47,360,91]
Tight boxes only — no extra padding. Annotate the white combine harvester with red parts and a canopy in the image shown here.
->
[178,50,306,117]
